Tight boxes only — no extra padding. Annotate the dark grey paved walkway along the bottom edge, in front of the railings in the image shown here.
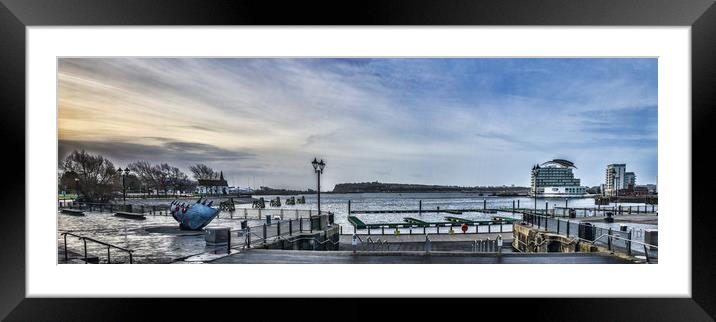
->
[208,249,628,264]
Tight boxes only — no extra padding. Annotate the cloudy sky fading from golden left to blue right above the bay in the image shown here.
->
[58,58,658,191]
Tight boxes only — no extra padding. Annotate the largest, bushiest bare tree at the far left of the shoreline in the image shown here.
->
[63,150,119,201]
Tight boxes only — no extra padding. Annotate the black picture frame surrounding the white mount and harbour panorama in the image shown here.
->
[0,0,716,321]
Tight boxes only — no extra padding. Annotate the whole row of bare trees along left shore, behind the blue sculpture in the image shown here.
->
[58,150,224,202]
